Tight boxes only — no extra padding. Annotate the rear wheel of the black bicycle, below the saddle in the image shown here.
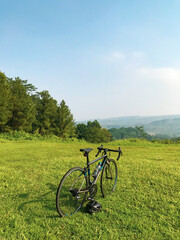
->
[56,167,87,217]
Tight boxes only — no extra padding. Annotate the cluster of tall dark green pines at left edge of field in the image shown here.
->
[0,72,75,138]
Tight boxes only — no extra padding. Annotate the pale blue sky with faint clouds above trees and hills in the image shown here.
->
[0,0,180,121]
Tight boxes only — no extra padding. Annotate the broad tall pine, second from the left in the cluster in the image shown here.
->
[7,78,36,131]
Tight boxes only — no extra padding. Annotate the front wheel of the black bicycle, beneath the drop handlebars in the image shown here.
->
[100,159,117,197]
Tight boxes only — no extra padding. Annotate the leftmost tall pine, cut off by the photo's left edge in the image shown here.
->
[0,72,11,132]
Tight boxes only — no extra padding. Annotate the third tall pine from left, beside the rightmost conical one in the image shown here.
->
[33,91,57,134]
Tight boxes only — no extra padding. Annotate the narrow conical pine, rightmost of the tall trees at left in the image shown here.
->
[56,100,75,138]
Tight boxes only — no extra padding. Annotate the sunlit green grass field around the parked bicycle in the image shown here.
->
[0,140,180,240]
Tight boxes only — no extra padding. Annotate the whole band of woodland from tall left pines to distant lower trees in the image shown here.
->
[0,72,179,143]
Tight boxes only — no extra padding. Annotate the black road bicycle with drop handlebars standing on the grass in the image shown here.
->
[56,145,122,217]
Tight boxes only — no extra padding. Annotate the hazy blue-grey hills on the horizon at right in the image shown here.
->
[78,114,180,137]
